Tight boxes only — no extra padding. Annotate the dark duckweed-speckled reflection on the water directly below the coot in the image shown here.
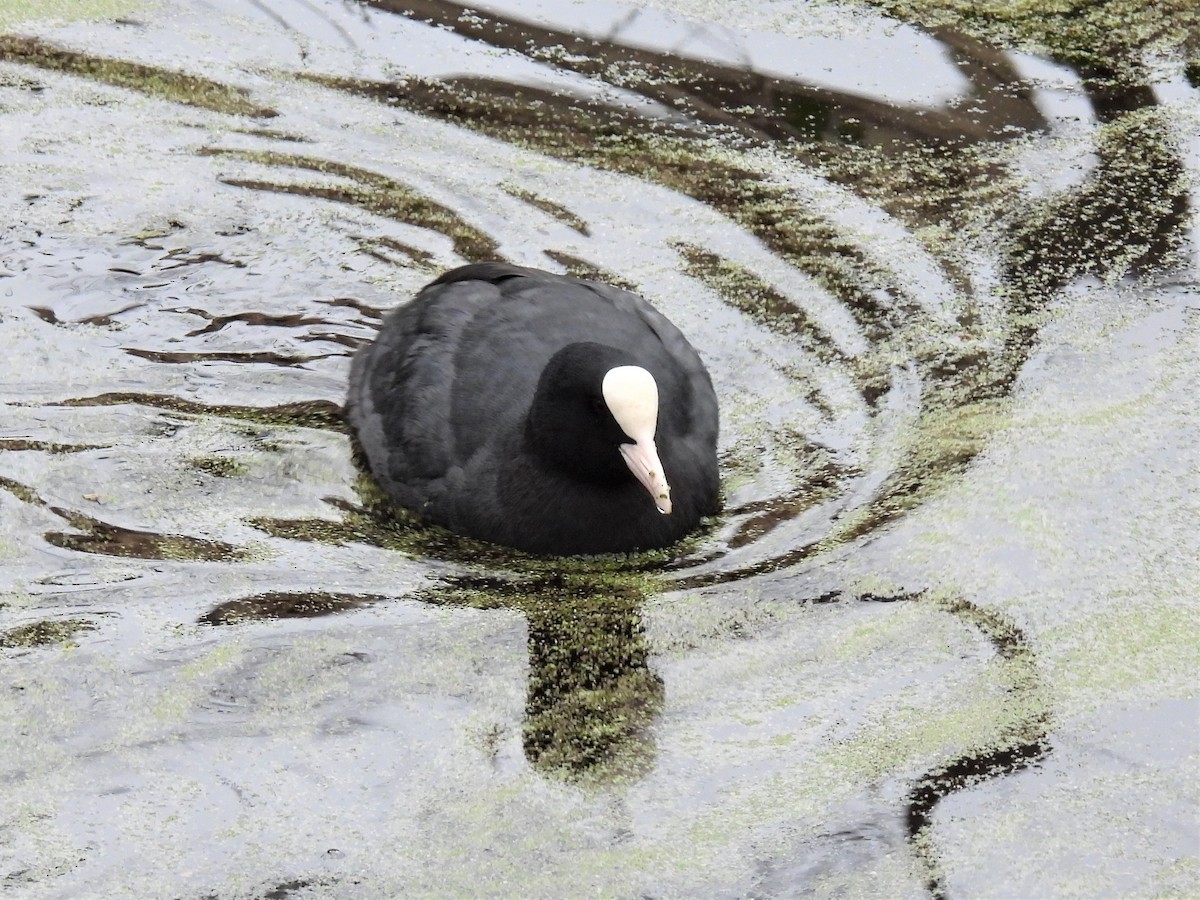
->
[249,475,679,781]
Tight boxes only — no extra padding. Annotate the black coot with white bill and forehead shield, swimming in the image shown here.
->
[347,263,718,554]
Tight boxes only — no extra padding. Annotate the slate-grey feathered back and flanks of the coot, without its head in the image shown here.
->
[347,263,718,550]
